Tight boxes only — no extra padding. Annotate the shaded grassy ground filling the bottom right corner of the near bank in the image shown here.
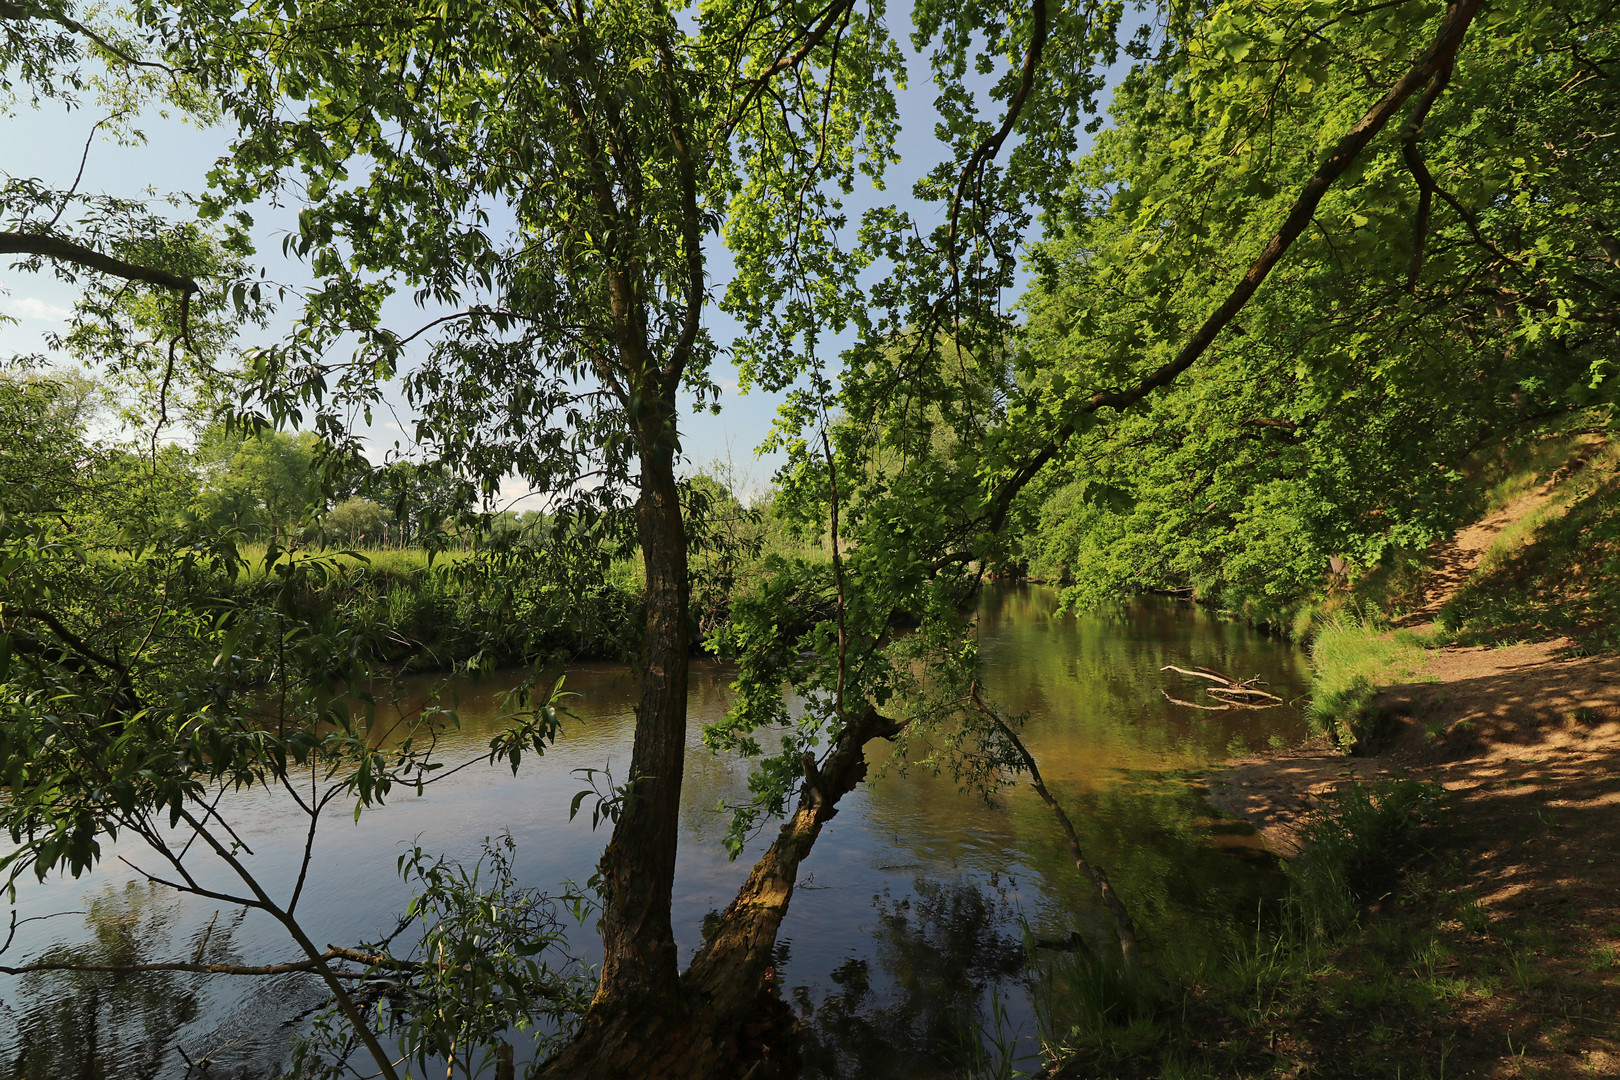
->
[1035,761,1620,1080]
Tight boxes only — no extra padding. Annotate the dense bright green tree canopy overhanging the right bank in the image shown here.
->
[1019,3,1620,625]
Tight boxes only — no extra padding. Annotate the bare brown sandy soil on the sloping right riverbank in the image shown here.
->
[1207,453,1620,1078]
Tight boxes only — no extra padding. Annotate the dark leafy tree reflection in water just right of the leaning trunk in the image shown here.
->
[791,879,1024,1077]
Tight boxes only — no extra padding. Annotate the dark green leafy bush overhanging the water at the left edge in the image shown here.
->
[0,540,375,881]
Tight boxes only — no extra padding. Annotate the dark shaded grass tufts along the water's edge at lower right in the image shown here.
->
[1034,779,1451,1080]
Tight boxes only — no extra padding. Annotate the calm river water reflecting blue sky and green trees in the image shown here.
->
[0,586,1306,1080]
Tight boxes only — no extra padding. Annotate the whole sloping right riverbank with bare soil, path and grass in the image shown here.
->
[1140,431,1620,1077]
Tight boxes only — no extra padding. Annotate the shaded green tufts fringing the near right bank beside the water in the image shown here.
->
[1034,779,1443,1077]
